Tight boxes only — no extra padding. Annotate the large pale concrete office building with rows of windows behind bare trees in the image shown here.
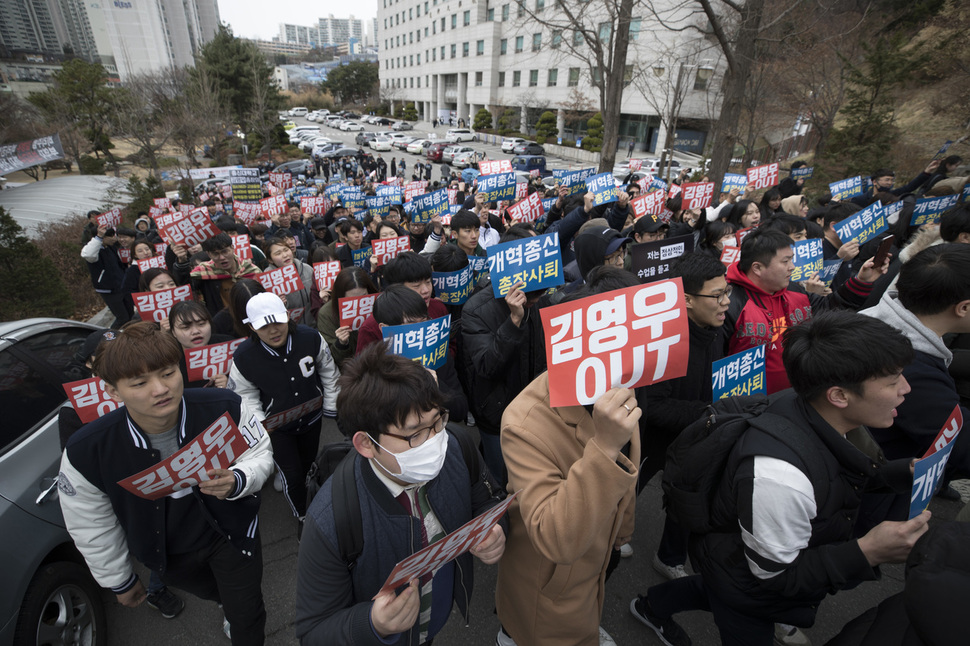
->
[377,0,723,152]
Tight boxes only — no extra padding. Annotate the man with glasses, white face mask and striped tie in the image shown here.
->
[296,343,506,646]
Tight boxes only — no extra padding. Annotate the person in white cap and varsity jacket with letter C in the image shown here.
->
[227,292,340,529]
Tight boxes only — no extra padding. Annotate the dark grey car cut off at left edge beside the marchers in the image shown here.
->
[0,318,108,646]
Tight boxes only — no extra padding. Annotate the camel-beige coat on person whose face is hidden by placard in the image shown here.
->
[495,373,640,646]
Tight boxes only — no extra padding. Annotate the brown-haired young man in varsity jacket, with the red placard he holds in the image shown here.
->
[58,322,273,644]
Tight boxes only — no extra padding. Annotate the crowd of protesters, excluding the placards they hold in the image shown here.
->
[60,147,970,646]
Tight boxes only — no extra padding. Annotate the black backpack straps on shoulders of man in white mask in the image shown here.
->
[306,424,506,570]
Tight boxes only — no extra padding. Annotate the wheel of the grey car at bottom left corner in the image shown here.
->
[14,561,108,646]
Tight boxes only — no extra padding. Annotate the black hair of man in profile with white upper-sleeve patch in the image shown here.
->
[781,310,913,401]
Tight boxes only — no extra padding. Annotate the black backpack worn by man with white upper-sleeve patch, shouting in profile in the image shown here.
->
[661,395,828,534]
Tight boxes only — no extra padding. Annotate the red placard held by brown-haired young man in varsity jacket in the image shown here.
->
[118,413,263,500]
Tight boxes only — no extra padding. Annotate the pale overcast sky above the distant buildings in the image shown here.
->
[218,0,377,40]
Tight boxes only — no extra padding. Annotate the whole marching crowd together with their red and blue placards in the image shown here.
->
[59,150,970,646]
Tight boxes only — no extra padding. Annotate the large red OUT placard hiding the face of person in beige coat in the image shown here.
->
[539,278,689,406]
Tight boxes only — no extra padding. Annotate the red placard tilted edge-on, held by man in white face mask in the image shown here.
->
[374,492,519,599]
